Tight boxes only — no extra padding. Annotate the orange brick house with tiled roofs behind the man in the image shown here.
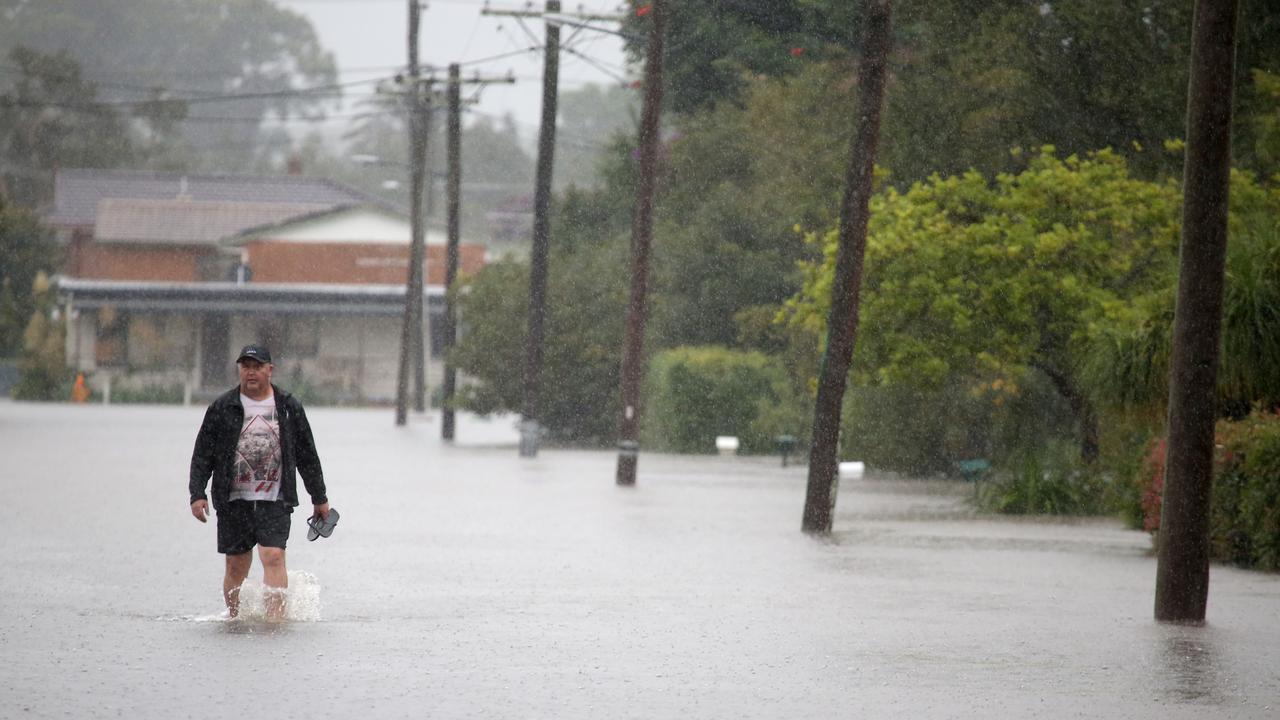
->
[47,170,485,402]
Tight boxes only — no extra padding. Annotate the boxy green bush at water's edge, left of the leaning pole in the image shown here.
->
[644,346,800,454]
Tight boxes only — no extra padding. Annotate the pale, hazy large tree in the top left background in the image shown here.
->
[0,0,340,172]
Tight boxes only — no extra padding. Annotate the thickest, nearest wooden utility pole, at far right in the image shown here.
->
[1156,0,1238,623]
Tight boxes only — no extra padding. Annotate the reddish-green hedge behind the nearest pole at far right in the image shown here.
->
[1138,411,1280,570]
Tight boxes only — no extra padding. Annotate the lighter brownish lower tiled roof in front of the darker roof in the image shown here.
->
[93,199,332,245]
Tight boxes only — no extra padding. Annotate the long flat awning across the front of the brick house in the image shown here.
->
[55,277,444,315]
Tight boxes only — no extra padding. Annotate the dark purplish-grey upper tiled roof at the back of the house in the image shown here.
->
[49,169,403,227]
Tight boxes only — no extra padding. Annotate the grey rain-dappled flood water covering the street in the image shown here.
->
[0,401,1280,719]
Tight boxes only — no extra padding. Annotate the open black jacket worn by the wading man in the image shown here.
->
[188,386,329,511]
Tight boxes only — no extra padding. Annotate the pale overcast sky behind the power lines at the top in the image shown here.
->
[275,0,631,142]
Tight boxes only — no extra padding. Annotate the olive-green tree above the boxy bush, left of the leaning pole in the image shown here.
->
[652,63,851,348]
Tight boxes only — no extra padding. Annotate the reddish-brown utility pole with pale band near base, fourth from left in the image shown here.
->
[617,0,667,486]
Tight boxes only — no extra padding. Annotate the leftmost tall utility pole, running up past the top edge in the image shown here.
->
[396,0,426,425]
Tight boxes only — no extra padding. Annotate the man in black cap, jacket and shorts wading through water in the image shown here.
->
[188,345,329,620]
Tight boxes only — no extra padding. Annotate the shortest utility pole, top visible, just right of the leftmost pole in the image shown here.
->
[440,63,462,439]
